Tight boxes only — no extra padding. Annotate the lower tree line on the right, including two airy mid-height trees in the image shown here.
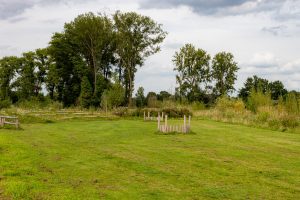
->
[135,44,300,107]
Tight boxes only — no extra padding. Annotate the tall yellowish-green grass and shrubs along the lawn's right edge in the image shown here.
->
[194,92,300,133]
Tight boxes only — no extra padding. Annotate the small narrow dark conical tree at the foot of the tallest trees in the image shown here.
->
[80,76,93,108]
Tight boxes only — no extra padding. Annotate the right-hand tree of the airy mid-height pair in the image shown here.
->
[211,52,239,96]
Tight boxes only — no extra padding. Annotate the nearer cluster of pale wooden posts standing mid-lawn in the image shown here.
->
[157,115,191,133]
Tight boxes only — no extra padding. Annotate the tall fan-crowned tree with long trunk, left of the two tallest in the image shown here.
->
[65,13,115,98]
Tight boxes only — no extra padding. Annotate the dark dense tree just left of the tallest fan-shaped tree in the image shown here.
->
[46,33,84,106]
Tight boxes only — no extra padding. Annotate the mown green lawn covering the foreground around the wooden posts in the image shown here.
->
[0,120,300,199]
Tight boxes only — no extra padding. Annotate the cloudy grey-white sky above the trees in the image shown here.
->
[0,0,300,92]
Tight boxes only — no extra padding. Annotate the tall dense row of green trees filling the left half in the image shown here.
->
[0,11,167,107]
